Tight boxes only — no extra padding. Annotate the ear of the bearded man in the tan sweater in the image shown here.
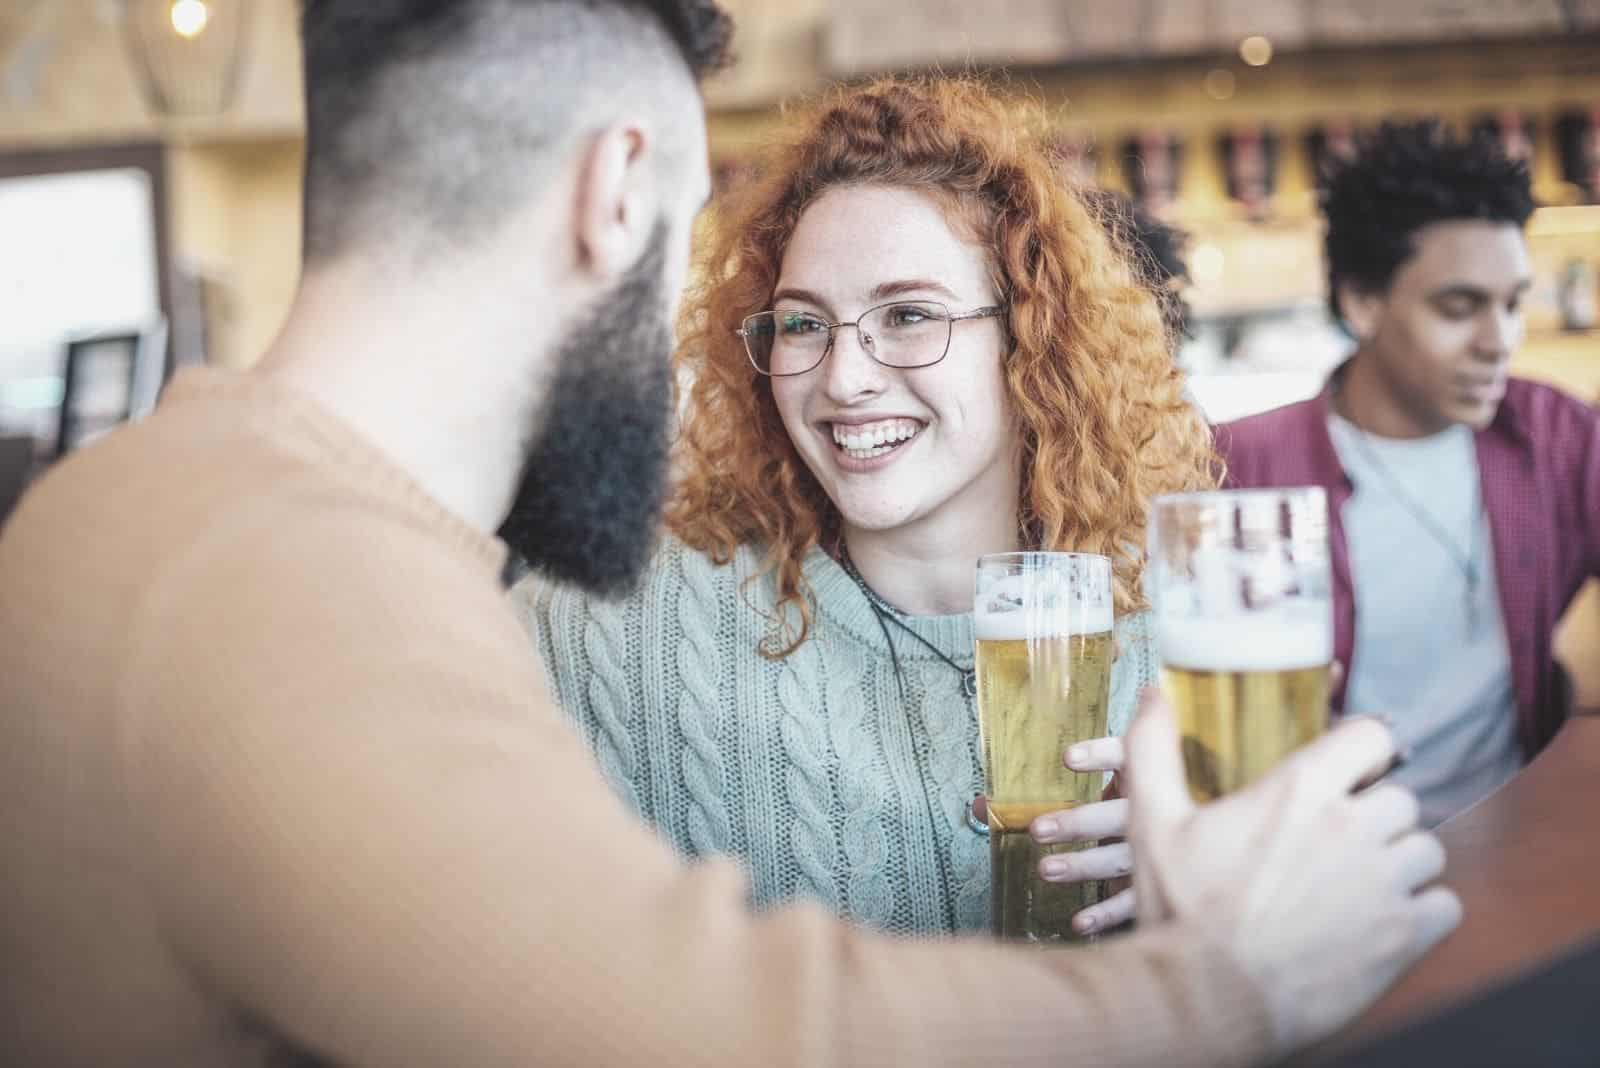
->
[573,120,659,283]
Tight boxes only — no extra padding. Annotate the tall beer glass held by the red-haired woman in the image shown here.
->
[973,553,1114,942]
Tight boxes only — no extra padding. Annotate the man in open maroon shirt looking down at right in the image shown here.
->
[1218,122,1600,823]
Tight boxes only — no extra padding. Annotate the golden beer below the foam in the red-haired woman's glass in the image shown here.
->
[978,626,1114,942]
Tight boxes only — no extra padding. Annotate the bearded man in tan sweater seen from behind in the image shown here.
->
[0,8,1459,1068]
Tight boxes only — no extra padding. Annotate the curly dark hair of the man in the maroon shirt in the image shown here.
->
[1318,118,1534,320]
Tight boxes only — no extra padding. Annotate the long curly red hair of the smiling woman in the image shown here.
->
[667,78,1218,656]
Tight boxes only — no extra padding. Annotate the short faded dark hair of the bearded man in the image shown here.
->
[301,0,731,262]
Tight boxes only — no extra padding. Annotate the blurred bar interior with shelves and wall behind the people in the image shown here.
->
[0,0,1600,703]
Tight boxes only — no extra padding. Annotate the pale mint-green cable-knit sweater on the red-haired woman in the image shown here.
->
[512,539,1157,935]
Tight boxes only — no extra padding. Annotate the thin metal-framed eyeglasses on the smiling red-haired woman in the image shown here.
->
[733,301,1005,377]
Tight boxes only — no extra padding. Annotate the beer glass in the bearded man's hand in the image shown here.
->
[1146,486,1333,801]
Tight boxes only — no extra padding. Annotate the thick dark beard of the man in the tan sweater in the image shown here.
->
[499,224,672,593]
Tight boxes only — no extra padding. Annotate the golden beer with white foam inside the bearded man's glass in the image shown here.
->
[1162,612,1331,801]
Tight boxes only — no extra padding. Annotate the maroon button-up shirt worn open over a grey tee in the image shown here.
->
[1216,373,1600,758]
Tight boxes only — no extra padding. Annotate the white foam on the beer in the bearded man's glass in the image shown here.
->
[1157,604,1333,671]
